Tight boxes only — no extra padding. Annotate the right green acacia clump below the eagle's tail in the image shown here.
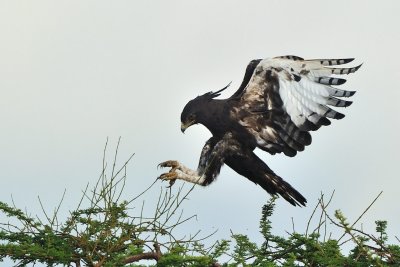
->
[225,192,400,267]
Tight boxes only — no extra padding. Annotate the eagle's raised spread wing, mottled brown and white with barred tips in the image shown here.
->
[231,56,361,156]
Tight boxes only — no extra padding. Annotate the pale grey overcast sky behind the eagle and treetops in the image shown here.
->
[0,0,400,266]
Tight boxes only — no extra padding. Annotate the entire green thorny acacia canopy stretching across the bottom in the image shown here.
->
[0,142,400,266]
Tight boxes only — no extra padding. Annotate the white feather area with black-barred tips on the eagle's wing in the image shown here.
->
[253,58,360,127]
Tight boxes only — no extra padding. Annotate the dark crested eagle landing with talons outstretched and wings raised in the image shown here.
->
[158,55,362,206]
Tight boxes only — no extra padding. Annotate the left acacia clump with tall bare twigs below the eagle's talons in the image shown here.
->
[0,141,219,266]
